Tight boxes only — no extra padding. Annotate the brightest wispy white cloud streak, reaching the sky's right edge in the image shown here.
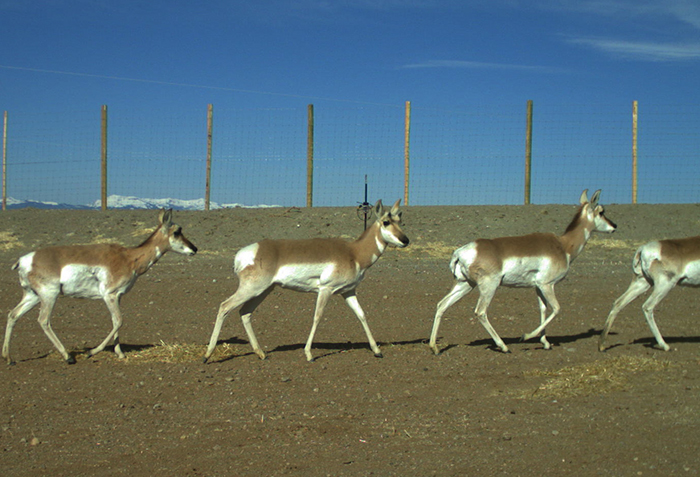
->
[569,38,700,61]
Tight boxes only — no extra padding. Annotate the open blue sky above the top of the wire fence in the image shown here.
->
[0,0,700,205]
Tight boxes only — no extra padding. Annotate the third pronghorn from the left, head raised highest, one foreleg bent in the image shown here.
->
[430,189,617,354]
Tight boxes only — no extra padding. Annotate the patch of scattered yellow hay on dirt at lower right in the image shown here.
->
[523,356,673,399]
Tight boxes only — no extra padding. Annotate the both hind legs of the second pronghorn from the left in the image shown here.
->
[203,279,272,363]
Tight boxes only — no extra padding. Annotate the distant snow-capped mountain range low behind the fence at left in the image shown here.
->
[7,195,279,210]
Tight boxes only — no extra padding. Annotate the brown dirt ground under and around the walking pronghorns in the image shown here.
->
[0,199,700,476]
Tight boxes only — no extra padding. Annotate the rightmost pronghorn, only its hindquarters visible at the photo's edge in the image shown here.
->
[598,236,700,351]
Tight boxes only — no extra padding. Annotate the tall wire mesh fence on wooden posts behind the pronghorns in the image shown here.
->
[3,103,700,207]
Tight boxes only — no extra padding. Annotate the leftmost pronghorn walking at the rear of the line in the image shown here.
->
[2,209,197,364]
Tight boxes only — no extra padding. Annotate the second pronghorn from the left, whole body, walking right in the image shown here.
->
[204,199,408,363]
